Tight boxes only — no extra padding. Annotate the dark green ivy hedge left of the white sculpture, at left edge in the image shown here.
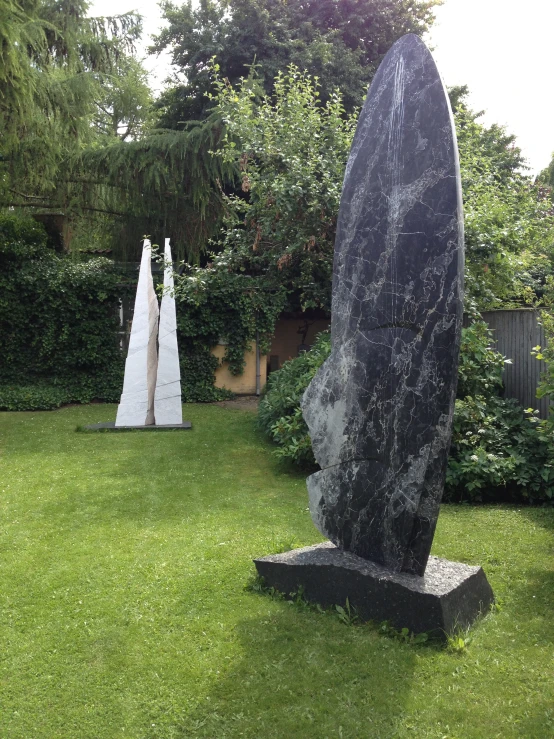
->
[0,214,127,410]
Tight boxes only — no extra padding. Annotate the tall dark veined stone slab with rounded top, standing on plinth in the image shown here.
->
[302,35,463,575]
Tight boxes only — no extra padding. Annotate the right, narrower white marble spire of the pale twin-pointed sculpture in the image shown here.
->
[154,239,183,426]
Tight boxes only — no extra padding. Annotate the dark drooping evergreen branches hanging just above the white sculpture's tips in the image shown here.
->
[74,116,235,264]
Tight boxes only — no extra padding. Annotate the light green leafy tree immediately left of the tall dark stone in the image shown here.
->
[206,65,356,312]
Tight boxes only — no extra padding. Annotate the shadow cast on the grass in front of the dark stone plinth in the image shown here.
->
[172,608,417,739]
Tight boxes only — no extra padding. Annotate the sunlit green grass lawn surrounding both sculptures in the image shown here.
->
[0,405,554,739]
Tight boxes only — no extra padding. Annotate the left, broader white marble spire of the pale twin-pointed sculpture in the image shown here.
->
[115,239,159,427]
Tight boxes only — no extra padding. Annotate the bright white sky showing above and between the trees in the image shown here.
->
[90,0,554,173]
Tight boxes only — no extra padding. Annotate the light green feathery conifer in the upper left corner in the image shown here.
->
[0,0,144,234]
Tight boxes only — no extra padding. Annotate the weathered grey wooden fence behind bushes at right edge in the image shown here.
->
[482,309,549,418]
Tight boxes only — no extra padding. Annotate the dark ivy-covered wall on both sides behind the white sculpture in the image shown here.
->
[0,215,285,410]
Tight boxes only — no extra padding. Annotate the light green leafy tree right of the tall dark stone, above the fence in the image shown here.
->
[451,87,554,310]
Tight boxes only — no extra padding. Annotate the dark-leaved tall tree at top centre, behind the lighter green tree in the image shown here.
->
[151,0,441,128]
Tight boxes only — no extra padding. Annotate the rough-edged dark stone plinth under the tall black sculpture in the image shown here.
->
[254,542,494,636]
